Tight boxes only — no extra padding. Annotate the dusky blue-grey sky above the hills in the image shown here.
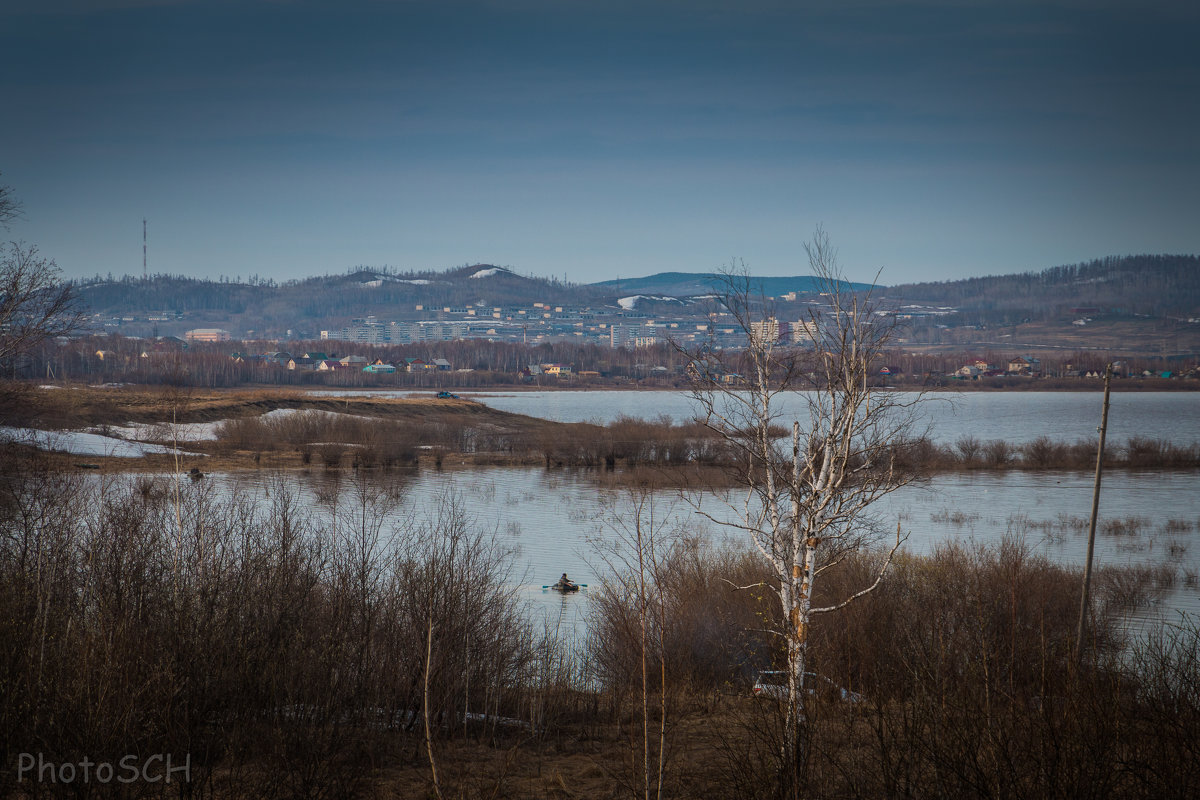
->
[0,0,1200,284]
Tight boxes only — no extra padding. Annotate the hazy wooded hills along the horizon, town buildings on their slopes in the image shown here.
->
[77,255,1200,351]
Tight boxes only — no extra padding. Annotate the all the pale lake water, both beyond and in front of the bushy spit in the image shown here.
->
[260,384,1200,627]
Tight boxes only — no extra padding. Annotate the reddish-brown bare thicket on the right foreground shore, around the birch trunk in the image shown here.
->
[593,539,1200,799]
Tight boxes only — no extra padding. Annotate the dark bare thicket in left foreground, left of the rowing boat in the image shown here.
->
[0,461,583,798]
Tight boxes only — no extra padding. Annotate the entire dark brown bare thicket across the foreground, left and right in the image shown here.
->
[0,459,1200,799]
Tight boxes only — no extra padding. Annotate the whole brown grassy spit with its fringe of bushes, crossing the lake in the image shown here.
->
[7,387,1200,486]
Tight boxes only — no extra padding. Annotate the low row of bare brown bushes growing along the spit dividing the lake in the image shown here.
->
[217,411,1200,473]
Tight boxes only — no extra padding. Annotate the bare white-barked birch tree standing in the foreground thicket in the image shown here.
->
[689,228,920,774]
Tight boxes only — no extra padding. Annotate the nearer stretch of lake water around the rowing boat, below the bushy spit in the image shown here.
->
[214,468,1200,632]
